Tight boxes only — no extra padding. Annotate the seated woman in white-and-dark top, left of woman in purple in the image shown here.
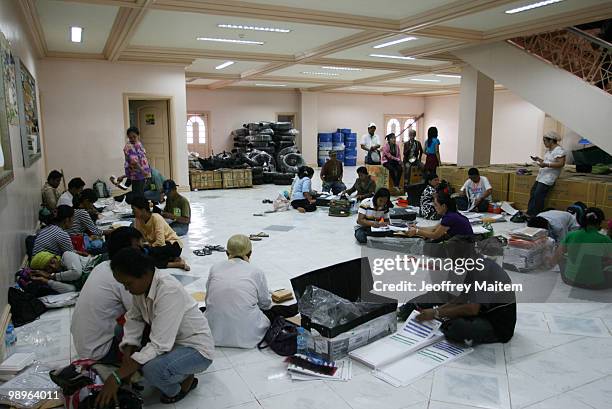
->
[355,187,391,244]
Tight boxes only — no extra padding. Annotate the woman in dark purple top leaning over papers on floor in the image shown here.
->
[406,192,474,241]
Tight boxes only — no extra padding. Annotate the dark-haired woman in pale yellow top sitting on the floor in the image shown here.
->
[132,196,191,271]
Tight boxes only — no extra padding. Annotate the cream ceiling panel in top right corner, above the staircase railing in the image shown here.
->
[444,0,610,31]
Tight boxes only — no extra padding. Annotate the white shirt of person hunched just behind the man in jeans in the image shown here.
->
[70,261,132,360]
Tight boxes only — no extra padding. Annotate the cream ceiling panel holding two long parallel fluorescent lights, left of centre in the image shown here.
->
[131,10,359,54]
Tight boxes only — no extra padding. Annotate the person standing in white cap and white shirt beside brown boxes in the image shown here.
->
[527,131,565,217]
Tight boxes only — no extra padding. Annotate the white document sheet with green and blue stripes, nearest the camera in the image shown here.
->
[374,340,473,388]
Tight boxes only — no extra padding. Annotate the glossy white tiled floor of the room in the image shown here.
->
[17,169,612,409]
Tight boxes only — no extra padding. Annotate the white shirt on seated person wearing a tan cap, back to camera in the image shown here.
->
[206,258,272,348]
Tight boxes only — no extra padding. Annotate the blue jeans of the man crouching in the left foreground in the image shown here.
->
[142,346,212,397]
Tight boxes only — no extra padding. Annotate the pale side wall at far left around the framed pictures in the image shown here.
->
[0,1,46,308]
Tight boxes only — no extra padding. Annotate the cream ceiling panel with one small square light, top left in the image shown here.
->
[36,0,119,53]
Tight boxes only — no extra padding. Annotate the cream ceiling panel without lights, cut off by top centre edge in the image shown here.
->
[232,0,454,20]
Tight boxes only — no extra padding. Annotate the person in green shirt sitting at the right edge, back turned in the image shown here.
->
[553,207,612,290]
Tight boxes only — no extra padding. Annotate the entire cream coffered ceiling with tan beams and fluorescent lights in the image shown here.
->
[19,0,612,95]
